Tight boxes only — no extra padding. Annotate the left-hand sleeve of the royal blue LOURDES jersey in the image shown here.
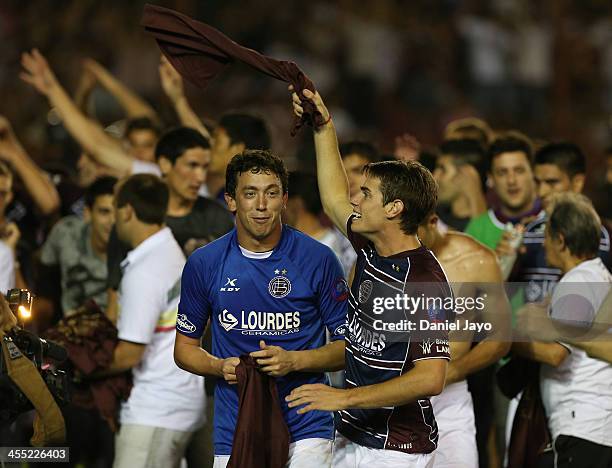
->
[176,250,211,338]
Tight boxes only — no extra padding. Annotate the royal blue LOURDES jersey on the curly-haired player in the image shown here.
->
[176,226,348,455]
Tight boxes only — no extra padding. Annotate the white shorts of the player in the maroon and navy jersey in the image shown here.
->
[332,431,434,468]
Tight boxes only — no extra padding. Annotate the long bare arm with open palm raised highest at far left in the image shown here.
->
[20,49,133,174]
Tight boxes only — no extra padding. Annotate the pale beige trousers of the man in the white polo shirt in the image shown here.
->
[113,424,193,468]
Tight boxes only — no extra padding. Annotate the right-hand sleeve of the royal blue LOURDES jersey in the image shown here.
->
[319,250,348,341]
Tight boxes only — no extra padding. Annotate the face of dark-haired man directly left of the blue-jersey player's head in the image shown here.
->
[159,147,210,201]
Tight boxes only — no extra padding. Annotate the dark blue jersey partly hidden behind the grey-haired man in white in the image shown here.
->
[513,211,612,302]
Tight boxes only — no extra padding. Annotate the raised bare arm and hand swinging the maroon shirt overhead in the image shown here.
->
[289,87,353,236]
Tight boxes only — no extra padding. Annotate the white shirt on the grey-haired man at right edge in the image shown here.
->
[540,258,612,447]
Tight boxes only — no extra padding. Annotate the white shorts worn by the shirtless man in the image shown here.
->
[430,380,478,468]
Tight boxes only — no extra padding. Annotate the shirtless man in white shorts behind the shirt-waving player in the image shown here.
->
[418,214,510,468]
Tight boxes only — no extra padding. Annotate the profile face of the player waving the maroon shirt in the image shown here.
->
[351,176,387,234]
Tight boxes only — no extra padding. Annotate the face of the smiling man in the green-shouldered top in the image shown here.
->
[491,151,535,213]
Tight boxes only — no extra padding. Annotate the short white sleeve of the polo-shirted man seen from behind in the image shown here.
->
[117,274,165,344]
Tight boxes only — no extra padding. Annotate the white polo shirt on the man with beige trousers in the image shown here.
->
[117,227,206,431]
